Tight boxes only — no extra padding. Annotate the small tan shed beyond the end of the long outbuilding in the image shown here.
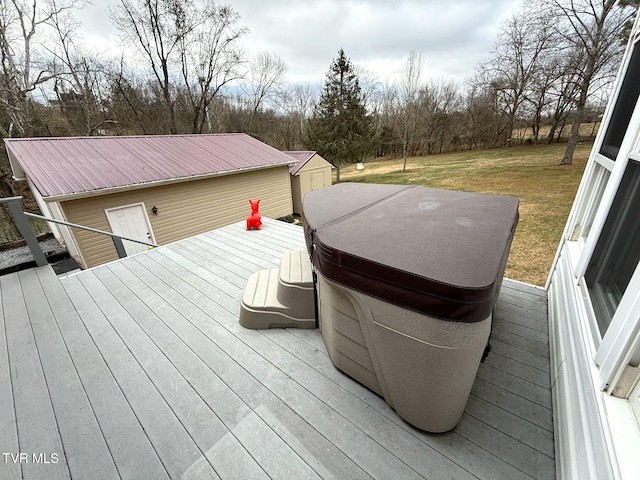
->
[284,150,333,214]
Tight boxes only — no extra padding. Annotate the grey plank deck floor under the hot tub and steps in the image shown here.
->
[0,220,555,480]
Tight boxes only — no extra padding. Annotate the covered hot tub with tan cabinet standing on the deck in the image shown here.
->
[303,183,518,432]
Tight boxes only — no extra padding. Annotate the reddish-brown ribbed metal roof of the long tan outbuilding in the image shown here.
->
[4,133,292,197]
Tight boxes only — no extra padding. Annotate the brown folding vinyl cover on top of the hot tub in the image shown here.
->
[303,183,518,323]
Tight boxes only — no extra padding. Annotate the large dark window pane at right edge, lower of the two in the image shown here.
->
[585,160,640,336]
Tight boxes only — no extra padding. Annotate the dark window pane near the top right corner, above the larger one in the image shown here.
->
[600,44,640,160]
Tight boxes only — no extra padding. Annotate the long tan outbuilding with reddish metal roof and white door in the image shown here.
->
[5,134,295,268]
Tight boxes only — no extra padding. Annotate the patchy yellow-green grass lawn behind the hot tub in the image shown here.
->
[334,143,592,286]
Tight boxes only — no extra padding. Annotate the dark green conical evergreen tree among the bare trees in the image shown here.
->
[306,49,374,182]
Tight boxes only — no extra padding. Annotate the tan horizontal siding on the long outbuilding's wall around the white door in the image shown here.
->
[60,166,293,268]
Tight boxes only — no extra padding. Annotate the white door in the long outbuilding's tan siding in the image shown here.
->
[105,203,155,256]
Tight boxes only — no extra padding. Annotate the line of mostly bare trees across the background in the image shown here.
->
[0,0,640,204]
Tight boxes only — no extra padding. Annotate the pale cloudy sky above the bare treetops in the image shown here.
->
[77,0,520,85]
